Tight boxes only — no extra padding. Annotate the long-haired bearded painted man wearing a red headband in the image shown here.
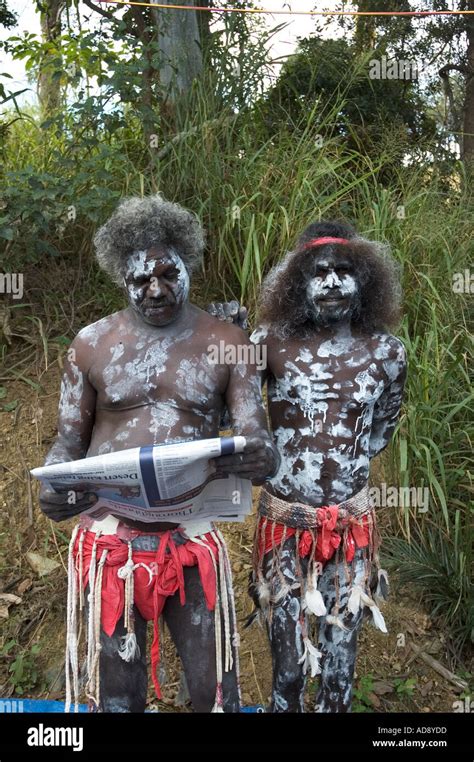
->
[209,222,406,712]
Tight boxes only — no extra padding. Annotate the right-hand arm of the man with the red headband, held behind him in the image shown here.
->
[369,339,407,458]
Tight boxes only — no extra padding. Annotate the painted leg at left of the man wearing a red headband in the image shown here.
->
[263,537,306,713]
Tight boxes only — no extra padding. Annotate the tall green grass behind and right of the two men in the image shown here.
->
[1,75,473,654]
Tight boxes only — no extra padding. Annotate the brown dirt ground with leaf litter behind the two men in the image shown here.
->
[0,356,466,713]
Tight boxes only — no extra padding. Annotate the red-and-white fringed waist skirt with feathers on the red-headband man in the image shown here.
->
[249,488,388,660]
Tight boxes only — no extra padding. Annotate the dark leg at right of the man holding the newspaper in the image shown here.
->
[163,566,240,712]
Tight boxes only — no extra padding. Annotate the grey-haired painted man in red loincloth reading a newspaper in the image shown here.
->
[40,196,277,712]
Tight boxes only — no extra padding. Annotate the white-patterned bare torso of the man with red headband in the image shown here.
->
[254,330,404,506]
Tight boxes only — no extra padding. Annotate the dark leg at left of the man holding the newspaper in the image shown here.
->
[86,586,148,712]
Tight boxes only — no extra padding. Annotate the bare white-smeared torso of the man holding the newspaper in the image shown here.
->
[85,311,227,456]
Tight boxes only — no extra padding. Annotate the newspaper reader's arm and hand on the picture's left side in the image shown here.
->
[39,335,97,521]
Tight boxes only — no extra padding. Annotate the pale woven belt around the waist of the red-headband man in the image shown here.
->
[258,485,372,529]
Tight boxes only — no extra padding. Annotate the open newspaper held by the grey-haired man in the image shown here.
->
[31,437,252,524]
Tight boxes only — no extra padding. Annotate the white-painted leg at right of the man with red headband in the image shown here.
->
[315,551,364,713]
